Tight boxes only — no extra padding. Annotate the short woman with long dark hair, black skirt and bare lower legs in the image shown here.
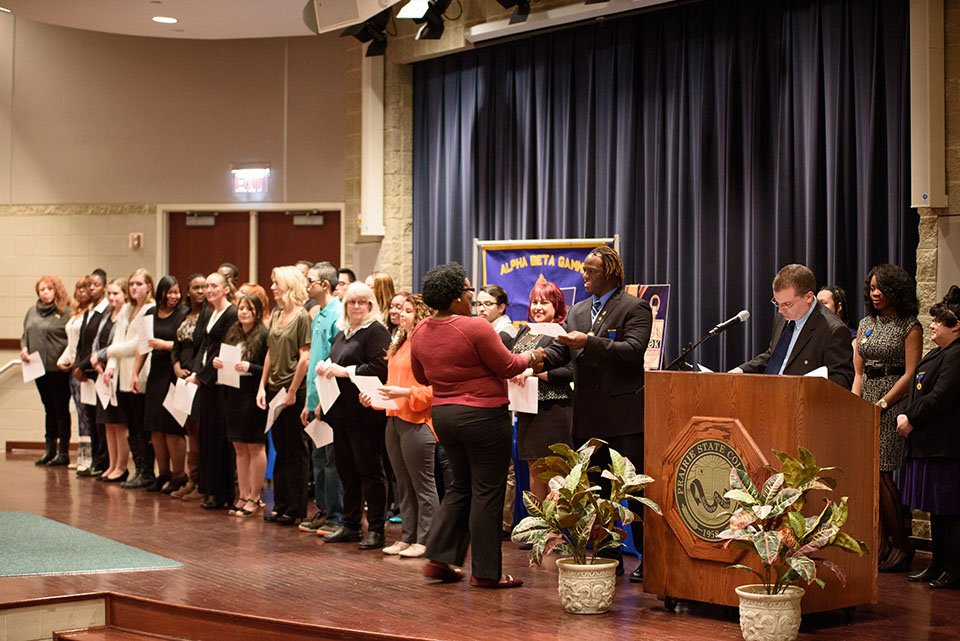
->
[213,294,267,516]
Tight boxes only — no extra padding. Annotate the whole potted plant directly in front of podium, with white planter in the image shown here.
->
[718,447,867,641]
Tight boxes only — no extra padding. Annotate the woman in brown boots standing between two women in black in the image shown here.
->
[170,274,207,500]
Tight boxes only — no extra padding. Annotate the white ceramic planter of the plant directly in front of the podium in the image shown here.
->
[737,584,806,641]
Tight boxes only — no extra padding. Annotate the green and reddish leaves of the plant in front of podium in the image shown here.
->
[718,447,867,594]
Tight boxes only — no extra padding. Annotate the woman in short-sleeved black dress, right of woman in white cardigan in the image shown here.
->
[134,275,188,494]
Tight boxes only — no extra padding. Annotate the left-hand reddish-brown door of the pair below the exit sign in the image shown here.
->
[169,211,250,285]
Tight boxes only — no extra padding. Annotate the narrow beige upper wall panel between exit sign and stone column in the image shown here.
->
[286,33,352,202]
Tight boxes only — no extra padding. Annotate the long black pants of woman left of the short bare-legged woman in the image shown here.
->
[194,384,236,504]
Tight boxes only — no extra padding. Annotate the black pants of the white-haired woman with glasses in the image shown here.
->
[331,414,387,534]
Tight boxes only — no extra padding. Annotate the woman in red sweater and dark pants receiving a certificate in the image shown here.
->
[410,263,543,588]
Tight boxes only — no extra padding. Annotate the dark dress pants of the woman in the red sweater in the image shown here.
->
[426,405,513,581]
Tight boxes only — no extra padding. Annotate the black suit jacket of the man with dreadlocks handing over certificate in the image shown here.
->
[544,289,653,443]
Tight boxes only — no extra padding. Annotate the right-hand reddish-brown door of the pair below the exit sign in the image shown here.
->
[257,211,340,284]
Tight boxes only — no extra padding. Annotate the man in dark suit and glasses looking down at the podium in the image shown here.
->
[731,264,853,389]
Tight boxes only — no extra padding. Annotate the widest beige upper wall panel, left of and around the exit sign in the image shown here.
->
[13,20,284,203]
